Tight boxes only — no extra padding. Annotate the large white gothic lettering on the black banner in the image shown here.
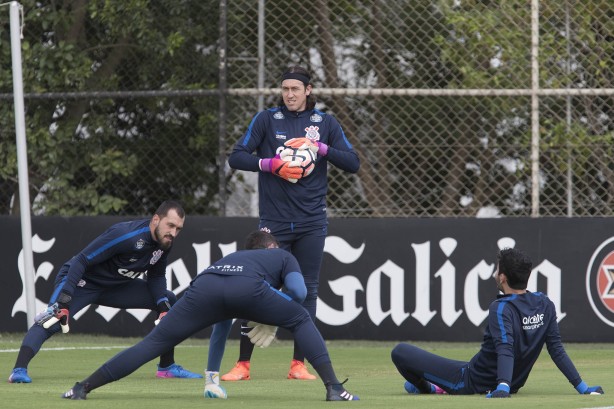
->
[11,235,566,327]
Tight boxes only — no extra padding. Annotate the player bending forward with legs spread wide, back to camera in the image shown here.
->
[62,231,358,401]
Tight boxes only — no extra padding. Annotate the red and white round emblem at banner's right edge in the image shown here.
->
[586,237,614,327]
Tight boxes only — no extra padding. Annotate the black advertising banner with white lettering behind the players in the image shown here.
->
[0,216,614,342]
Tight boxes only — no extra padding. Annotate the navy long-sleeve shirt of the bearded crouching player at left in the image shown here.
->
[52,219,169,303]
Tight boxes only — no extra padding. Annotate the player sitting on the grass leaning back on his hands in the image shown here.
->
[392,248,603,398]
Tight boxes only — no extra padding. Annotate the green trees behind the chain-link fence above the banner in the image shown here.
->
[0,0,614,217]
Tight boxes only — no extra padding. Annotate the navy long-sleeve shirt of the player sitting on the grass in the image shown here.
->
[468,292,581,393]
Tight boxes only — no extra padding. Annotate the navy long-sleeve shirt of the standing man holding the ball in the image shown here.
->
[228,106,360,222]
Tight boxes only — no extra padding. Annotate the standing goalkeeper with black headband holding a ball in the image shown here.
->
[208,66,360,381]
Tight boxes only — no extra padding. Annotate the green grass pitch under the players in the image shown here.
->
[0,334,614,409]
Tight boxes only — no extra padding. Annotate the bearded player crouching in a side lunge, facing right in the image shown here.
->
[9,200,202,383]
